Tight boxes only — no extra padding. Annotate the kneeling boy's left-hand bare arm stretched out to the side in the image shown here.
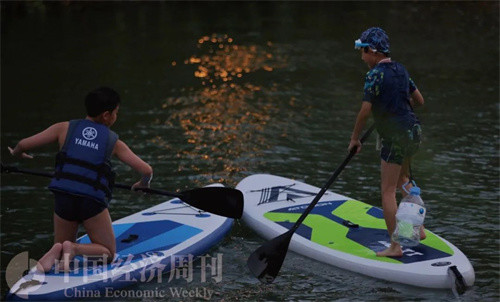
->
[8,122,68,159]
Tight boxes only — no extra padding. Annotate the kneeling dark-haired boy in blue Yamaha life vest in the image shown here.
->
[9,87,153,272]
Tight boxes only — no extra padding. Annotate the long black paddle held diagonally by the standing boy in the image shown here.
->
[247,125,375,283]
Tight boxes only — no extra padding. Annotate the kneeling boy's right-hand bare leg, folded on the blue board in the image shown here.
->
[63,209,116,271]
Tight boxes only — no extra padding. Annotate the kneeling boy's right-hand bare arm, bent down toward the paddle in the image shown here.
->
[113,140,153,188]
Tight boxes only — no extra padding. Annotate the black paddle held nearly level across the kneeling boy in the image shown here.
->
[1,163,243,218]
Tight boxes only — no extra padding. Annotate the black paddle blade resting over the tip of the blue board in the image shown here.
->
[179,187,243,218]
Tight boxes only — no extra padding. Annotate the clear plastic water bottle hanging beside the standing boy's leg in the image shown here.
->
[392,182,425,246]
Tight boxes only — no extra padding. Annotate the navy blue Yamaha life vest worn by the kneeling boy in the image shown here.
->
[49,120,118,206]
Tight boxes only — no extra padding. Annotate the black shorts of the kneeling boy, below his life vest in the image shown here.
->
[52,191,106,222]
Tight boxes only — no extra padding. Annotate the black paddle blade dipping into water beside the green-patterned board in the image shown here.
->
[247,231,293,283]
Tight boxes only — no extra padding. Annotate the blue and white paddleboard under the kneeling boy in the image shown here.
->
[7,184,233,300]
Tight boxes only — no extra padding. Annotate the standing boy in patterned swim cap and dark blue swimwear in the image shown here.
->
[348,27,425,257]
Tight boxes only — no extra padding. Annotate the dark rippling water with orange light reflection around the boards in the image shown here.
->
[0,2,500,301]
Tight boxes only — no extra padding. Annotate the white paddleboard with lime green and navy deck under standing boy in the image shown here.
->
[236,174,475,289]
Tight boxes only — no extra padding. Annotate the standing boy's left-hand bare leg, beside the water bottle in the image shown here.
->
[377,160,403,257]
